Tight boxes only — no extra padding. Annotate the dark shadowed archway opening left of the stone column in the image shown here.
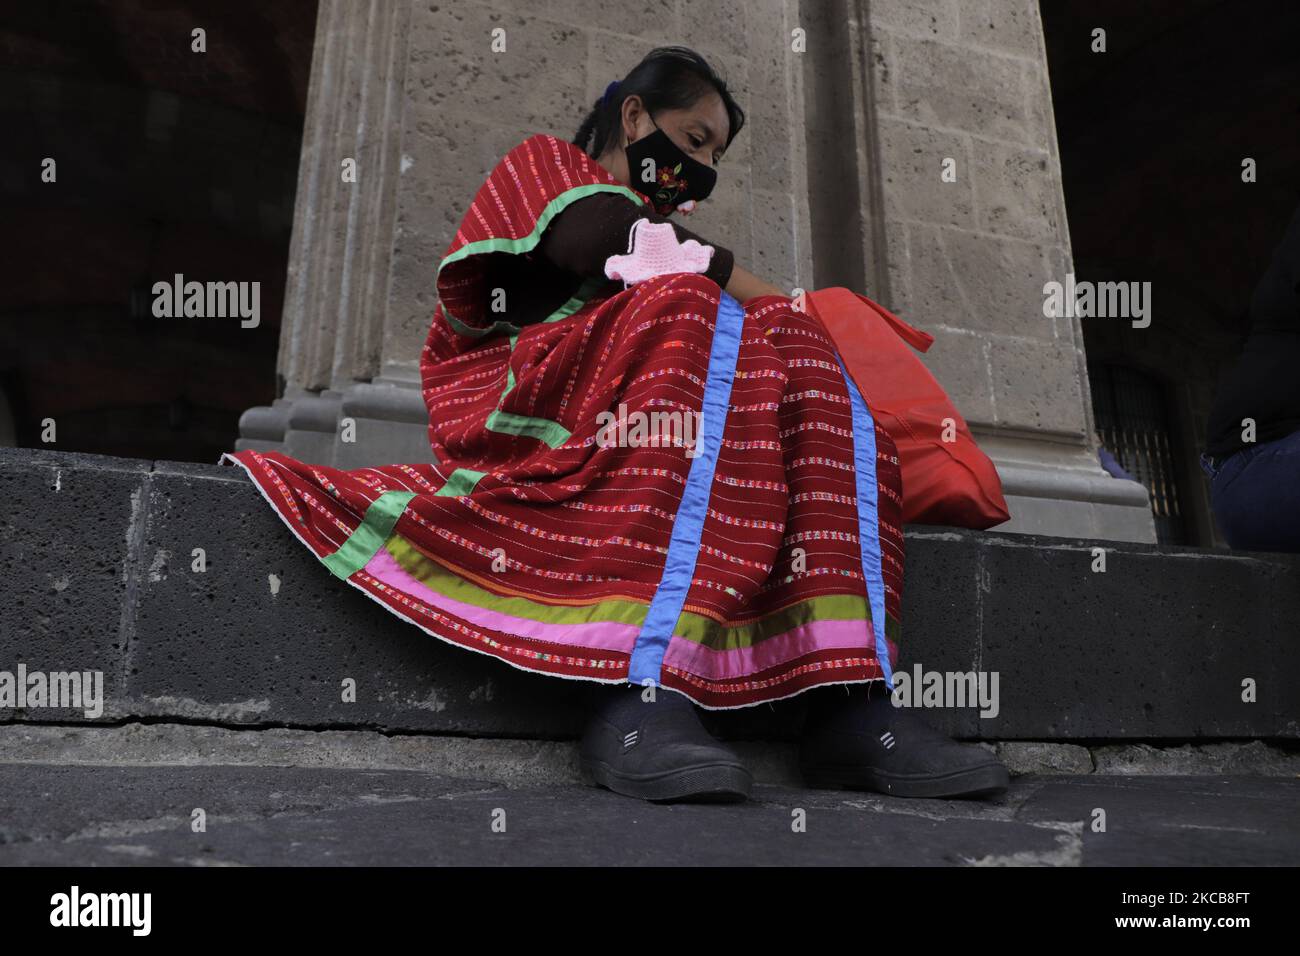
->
[0,0,316,463]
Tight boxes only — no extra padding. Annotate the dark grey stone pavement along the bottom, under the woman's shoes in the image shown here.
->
[0,762,1300,868]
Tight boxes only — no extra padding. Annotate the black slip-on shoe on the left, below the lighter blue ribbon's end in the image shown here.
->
[579,685,754,803]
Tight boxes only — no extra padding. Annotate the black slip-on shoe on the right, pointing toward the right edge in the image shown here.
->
[800,685,1010,797]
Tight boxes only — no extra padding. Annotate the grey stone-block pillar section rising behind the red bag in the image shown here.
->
[803,0,1154,541]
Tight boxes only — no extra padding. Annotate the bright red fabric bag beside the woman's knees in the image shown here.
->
[805,287,1011,528]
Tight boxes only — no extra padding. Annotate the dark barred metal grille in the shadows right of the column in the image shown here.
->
[1088,362,1188,545]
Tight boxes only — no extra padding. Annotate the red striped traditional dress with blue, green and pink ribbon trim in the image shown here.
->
[222,135,904,709]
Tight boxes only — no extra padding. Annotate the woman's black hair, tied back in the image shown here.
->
[573,47,745,159]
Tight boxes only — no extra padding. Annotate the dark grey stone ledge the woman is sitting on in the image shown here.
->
[0,449,1300,741]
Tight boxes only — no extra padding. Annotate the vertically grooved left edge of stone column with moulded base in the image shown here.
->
[237,0,432,468]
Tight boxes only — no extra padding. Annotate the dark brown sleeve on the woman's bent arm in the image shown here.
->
[537,193,736,289]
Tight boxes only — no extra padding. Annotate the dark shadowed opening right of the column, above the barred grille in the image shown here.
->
[1040,0,1300,546]
